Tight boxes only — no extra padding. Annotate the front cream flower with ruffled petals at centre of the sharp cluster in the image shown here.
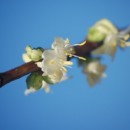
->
[42,50,73,75]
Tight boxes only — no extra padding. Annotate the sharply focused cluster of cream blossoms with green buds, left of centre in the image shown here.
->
[23,38,73,94]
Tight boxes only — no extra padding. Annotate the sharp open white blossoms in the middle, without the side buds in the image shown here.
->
[36,38,73,92]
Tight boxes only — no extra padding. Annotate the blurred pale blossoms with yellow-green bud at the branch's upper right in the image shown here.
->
[88,19,130,58]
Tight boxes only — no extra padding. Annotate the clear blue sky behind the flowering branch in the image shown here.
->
[0,0,130,130]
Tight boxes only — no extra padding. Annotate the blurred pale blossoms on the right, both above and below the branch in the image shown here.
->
[80,19,130,86]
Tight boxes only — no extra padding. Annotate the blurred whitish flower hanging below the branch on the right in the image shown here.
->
[84,60,106,86]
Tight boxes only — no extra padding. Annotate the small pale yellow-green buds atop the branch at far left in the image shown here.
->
[22,46,43,62]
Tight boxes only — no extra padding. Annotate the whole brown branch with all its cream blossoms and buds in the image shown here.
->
[0,19,130,95]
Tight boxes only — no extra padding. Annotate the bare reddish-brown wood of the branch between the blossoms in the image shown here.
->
[0,41,102,87]
